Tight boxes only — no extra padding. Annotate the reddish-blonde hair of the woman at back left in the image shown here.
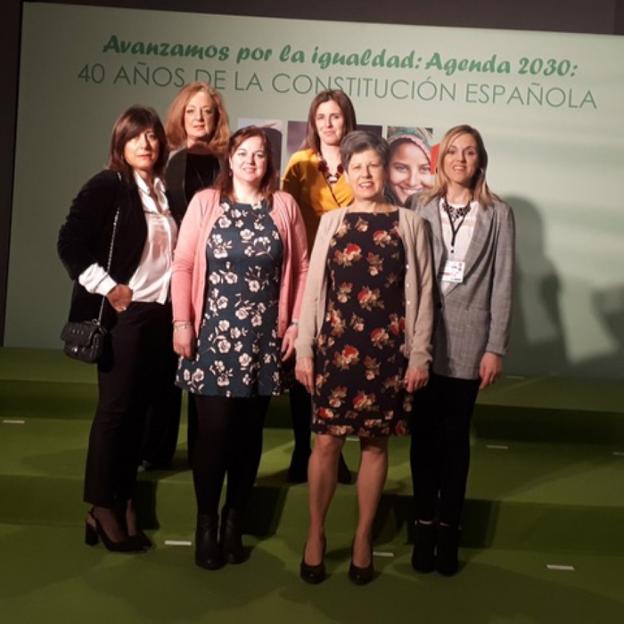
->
[165,80,230,154]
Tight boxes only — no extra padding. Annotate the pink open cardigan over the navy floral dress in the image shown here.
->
[171,189,308,337]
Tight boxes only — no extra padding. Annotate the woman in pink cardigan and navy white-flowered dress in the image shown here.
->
[171,126,308,570]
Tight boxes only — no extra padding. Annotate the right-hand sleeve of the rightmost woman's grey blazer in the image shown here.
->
[485,203,515,355]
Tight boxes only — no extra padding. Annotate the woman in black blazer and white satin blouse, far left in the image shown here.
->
[58,106,183,551]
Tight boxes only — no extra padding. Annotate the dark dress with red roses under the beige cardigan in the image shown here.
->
[312,211,412,437]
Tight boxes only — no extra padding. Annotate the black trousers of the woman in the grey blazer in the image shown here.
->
[410,374,479,527]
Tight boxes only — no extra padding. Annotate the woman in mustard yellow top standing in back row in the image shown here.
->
[282,90,356,483]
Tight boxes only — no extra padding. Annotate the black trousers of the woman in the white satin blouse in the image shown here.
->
[84,302,176,508]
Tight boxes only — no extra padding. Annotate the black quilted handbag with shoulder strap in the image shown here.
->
[61,206,119,364]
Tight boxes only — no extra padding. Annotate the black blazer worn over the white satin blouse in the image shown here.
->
[57,170,184,328]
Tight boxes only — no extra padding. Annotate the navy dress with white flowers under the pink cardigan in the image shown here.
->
[176,201,282,397]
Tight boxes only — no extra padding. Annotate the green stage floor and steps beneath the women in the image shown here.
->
[0,349,624,624]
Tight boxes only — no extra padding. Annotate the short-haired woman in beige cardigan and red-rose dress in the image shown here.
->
[296,131,433,584]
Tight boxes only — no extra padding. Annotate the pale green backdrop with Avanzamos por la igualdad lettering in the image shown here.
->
[5,3,624,377]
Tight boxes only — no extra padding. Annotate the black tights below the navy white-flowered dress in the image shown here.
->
[192,395,271,515]
